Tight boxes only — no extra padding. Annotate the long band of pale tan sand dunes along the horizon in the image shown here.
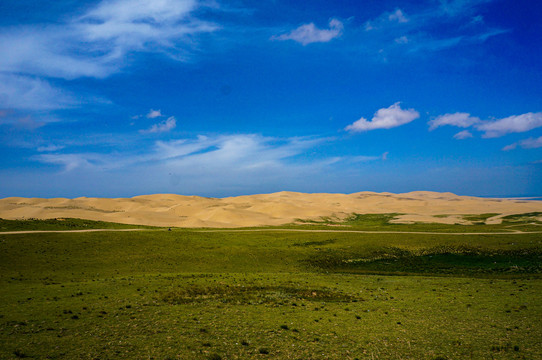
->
[0,191,542,227]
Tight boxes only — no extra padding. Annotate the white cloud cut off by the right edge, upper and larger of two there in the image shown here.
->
[476,112,542,138]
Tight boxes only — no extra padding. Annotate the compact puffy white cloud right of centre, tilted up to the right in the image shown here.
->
[345,102,420,132]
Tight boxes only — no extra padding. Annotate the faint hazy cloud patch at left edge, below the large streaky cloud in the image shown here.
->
[0,74,78,110]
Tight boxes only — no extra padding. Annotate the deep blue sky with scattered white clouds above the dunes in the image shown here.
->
[0,0,542,198]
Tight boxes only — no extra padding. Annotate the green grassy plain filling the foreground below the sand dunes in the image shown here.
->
[0,215,542,360]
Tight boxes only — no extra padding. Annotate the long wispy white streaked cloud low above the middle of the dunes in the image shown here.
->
[33,134,328,173]
